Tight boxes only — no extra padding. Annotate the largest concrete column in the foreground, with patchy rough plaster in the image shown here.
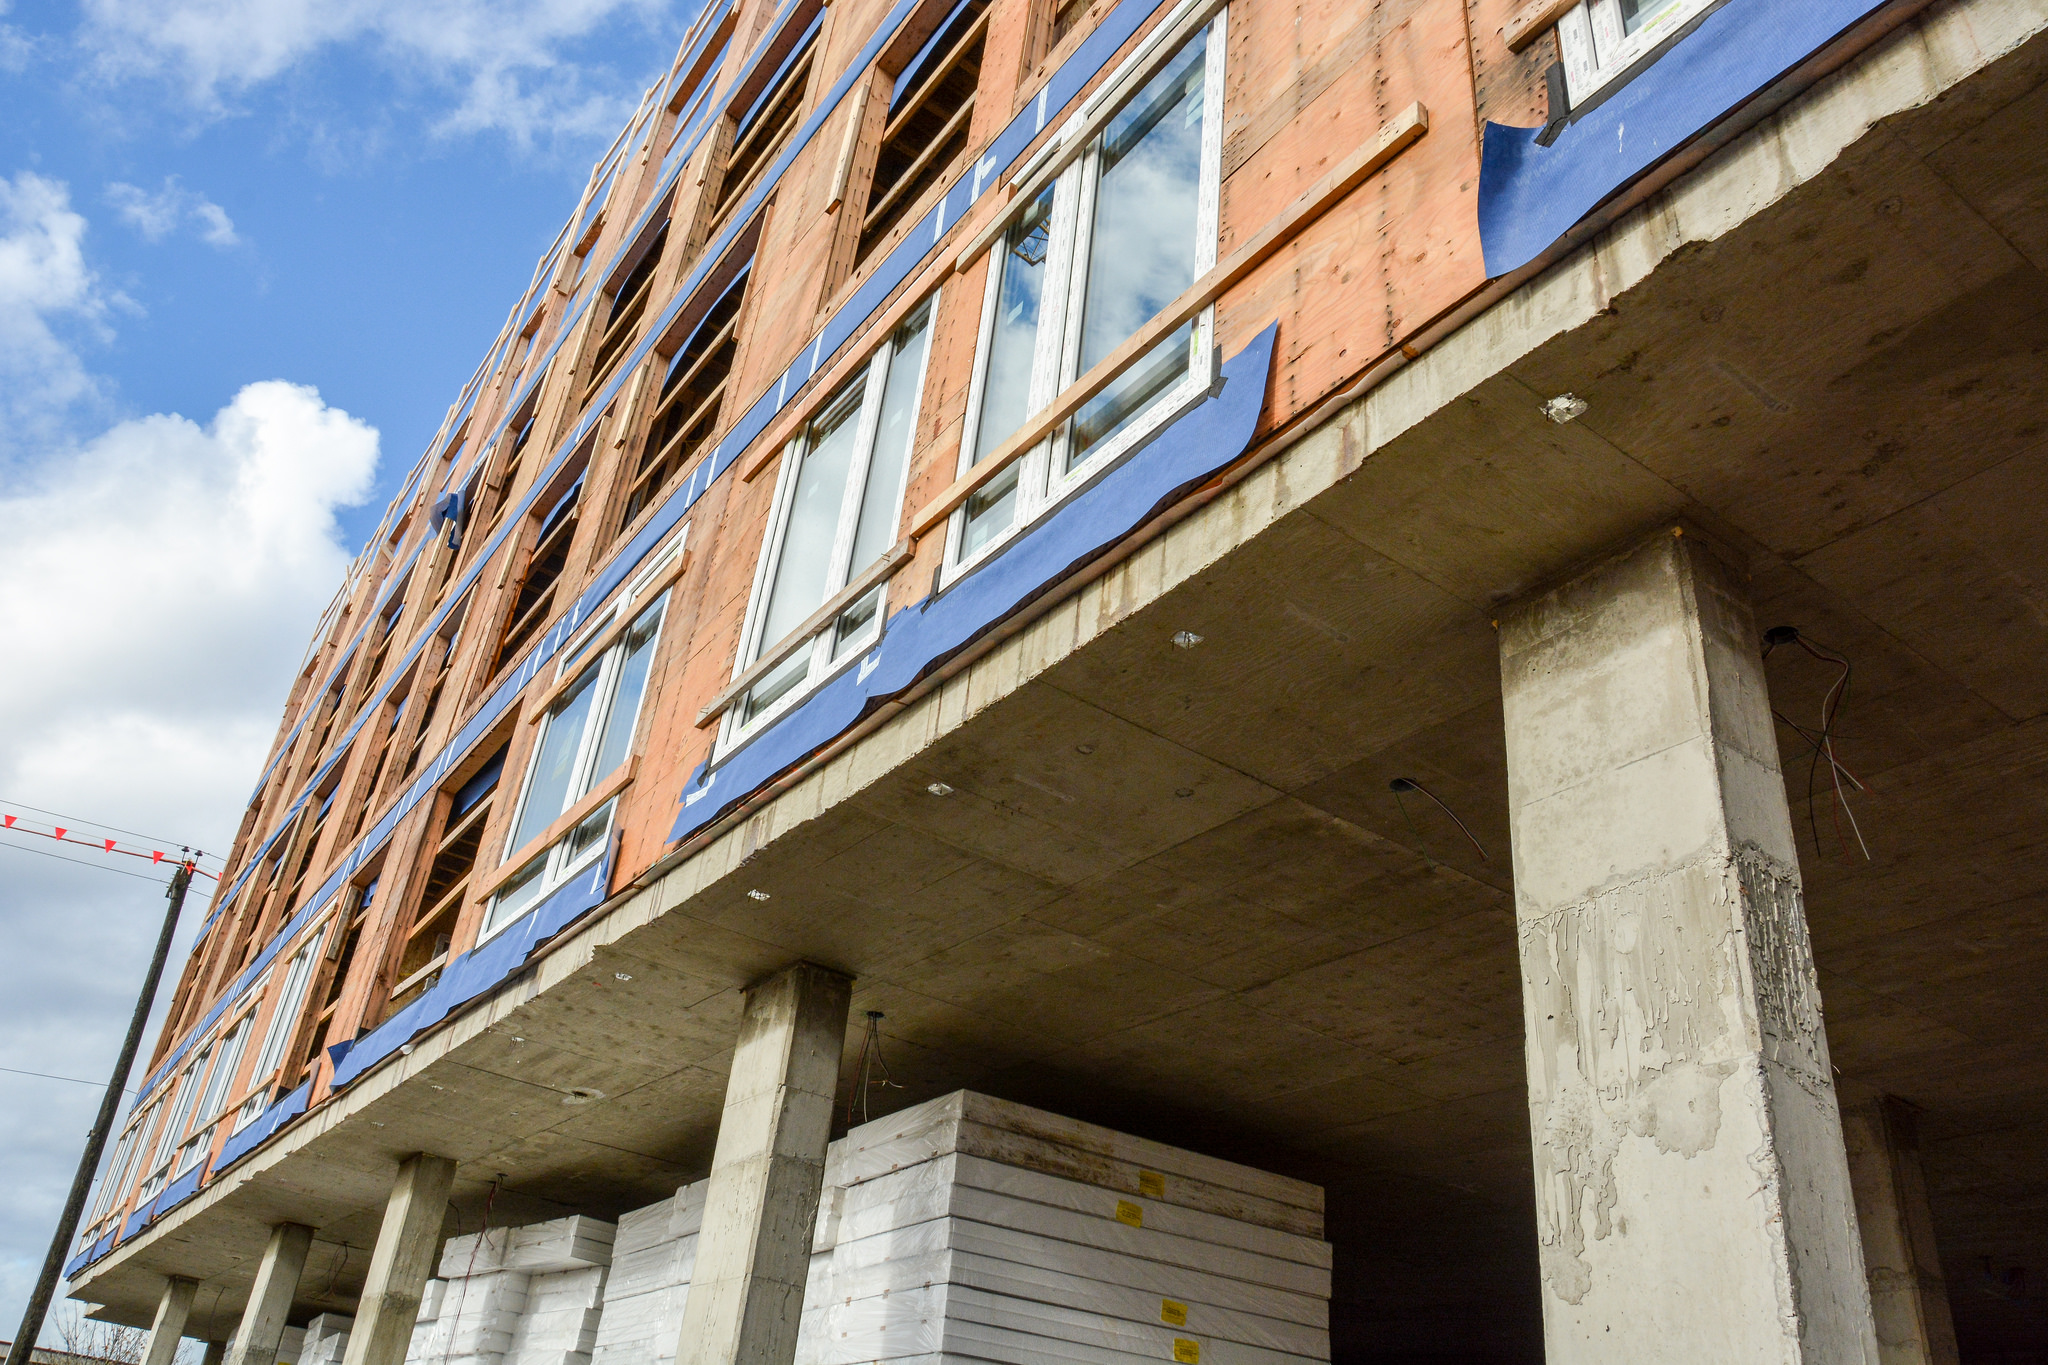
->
[1499,528,1878,1365]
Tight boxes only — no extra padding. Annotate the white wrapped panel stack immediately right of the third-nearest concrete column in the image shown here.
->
[406,1218,614,1365]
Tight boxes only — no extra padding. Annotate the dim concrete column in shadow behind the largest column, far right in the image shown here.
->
[1841,1095,1958,1365]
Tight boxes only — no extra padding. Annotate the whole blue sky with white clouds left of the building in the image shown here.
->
[0,0,694,1340]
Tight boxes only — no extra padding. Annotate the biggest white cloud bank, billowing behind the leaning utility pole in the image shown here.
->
[0,381,377,1322]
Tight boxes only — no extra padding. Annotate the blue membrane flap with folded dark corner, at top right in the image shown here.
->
[1479,0,1882,278]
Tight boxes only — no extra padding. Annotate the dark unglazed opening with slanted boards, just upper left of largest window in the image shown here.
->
[854,0,989,262]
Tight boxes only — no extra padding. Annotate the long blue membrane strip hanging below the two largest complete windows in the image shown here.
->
[668,325,1276,841]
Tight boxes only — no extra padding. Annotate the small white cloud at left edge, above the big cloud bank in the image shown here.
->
[0,170,106,454]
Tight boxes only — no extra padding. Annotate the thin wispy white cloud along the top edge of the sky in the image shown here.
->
[84,0,674,141]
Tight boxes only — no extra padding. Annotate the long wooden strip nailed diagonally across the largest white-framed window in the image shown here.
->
[909,102,1430,540]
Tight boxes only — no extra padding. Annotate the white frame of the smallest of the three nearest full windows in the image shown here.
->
[477,540,690,948]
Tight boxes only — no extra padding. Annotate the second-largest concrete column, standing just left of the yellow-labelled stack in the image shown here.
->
[675,962,852,1365]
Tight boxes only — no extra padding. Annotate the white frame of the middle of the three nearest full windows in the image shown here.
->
[717,304,938,759]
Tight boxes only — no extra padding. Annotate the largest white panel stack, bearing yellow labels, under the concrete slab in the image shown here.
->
[799,1091,1329,1365]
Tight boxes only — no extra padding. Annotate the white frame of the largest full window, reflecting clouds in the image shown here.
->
[940,8,1229,585]
